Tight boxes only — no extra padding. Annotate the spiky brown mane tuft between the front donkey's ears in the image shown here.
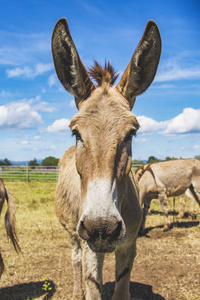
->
[88,60,119,86]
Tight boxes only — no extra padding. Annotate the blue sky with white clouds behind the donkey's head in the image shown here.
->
[0,0,200,160]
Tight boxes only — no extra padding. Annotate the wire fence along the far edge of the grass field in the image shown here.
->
[0,164,141,182]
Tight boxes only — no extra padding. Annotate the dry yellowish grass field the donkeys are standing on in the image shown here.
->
[0,182,200,300]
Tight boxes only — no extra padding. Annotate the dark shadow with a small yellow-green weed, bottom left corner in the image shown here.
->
[0,280,56,300]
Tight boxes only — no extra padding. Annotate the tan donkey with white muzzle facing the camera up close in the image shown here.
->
[52,18,161,300]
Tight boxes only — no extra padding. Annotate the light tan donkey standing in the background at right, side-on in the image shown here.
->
[136,158,200,233]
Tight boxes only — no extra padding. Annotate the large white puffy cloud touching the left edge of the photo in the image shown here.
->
[0,100,42,129]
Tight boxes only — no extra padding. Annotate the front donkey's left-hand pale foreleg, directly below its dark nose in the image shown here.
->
[83,242,104,300]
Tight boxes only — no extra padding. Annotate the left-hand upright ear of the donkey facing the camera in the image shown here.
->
[51,18,95,108]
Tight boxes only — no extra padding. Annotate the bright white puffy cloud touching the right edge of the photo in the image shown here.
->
[162,107,200,135]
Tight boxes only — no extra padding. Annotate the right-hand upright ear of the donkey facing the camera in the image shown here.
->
[116,21,161,109]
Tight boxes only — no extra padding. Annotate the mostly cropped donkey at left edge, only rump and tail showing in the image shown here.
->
[0,177,21,278]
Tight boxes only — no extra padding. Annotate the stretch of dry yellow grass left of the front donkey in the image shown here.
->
[0,182,72,300]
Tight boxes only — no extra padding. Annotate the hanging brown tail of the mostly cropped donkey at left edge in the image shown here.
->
[4,186,21,252]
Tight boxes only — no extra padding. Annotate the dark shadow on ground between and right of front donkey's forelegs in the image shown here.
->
[103,282,165,300]
